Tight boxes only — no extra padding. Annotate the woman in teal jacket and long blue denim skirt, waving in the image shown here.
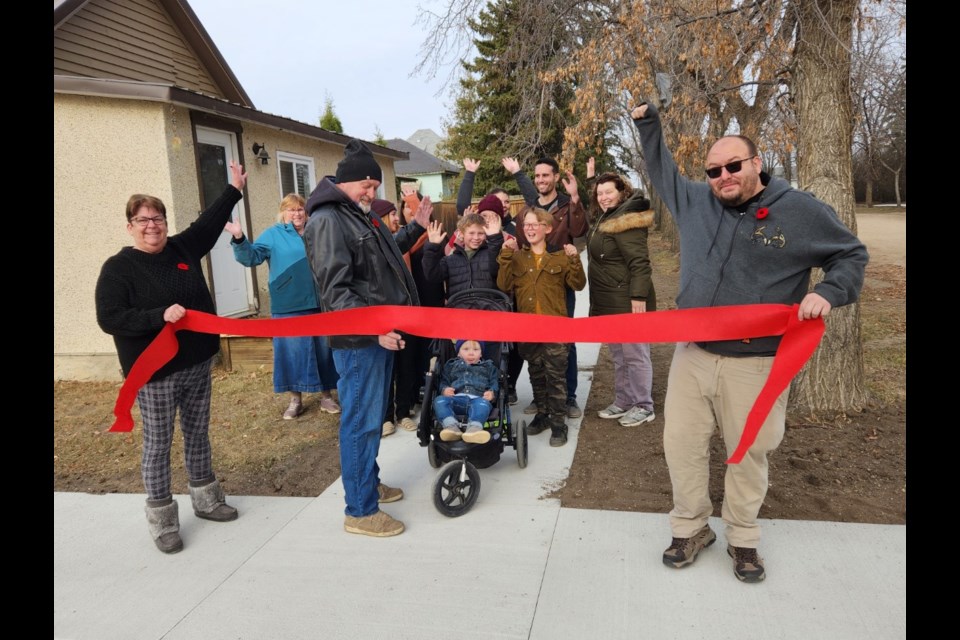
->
[224,193,340,420]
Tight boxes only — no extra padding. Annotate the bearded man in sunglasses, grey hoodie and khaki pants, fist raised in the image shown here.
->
[630,104,868,582]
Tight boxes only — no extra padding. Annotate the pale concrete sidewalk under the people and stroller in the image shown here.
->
[53,286,906,640]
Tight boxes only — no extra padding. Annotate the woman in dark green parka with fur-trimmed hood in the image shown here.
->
[587,173,657,427]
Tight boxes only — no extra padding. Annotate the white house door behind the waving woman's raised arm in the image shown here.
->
[197,127,255,317]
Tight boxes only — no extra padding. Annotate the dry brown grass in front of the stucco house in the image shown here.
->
[53,367,339,495]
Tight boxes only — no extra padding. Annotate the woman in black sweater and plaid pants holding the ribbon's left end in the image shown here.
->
[96,162,247,553]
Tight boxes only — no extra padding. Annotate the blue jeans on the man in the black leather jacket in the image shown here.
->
[333,344,393,518]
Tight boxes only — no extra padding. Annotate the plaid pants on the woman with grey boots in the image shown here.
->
[137,360,213,500]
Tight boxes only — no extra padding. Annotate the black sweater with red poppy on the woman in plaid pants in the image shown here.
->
[96,185,242,381]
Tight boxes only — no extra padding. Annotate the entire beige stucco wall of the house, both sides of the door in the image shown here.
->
[53,94,396,380]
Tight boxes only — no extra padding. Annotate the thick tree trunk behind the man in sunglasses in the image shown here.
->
[792,0,865,412]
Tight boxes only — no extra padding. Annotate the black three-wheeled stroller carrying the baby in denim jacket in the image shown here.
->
[417,289,527,518]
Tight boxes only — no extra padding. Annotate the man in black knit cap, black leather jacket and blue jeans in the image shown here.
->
[303,140,433,537]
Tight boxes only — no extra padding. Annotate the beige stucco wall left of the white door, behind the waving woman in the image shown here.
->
[52,94,197,379]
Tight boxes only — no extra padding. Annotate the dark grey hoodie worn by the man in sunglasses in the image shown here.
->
[634,105,868,356]
